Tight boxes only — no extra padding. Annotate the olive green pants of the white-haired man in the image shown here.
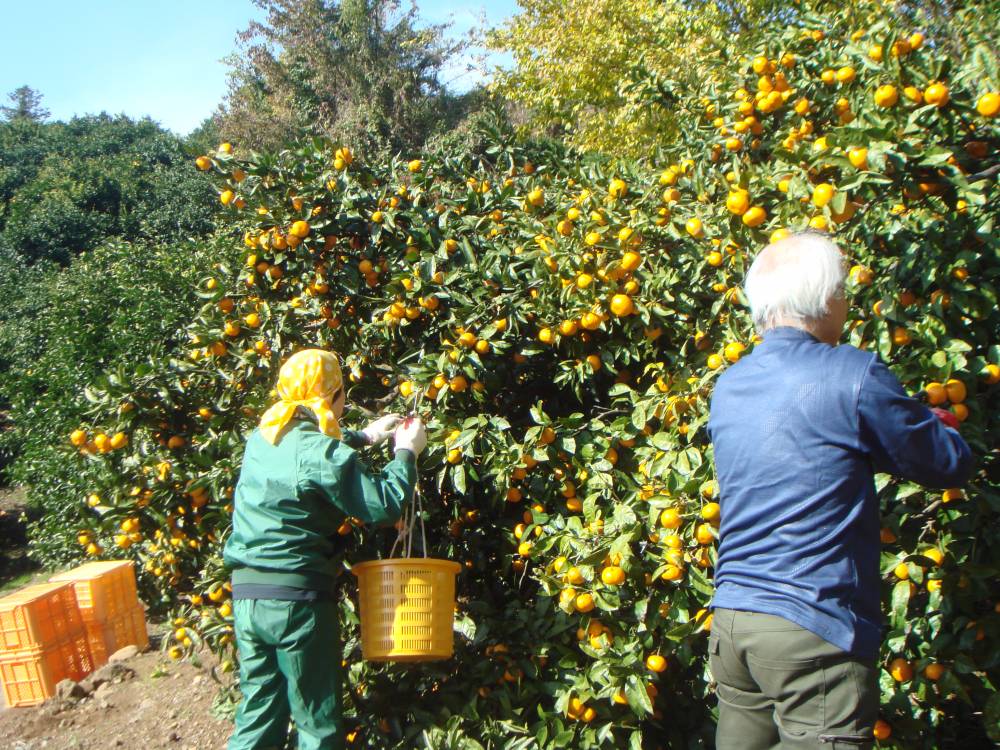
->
[708,609,879,750]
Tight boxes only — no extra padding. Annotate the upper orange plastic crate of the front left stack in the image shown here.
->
[0,583,83,655]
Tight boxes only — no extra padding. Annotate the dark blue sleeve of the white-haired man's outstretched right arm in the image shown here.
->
[858,359,973,488]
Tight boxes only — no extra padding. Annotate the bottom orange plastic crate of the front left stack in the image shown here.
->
[0,630,93,707]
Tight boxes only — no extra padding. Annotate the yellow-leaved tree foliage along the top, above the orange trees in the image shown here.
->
[490,0,996,158]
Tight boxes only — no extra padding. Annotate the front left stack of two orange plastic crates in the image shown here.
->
[0,583,93,706]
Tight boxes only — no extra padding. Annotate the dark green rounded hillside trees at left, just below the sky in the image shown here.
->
[0,114,214,264]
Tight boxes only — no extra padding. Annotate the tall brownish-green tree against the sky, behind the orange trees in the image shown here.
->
[219,0,474,157]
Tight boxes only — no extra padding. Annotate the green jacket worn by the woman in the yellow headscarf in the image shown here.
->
[223,420,417,591]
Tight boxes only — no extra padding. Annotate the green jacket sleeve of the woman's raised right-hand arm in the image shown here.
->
[308,440,417,525]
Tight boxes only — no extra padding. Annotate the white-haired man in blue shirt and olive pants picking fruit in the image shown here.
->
[708,233,972,750]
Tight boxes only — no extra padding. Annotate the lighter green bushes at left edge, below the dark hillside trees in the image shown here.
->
[0,238,236,516]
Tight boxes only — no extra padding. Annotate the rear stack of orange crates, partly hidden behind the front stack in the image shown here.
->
[51,560,149,667]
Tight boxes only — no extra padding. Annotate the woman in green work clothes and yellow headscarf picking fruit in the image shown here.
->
[224,349,427,750]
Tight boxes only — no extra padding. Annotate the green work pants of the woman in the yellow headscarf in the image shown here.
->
[229,599,344,750]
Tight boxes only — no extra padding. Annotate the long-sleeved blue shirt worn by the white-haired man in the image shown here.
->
[708,328,972,657]
